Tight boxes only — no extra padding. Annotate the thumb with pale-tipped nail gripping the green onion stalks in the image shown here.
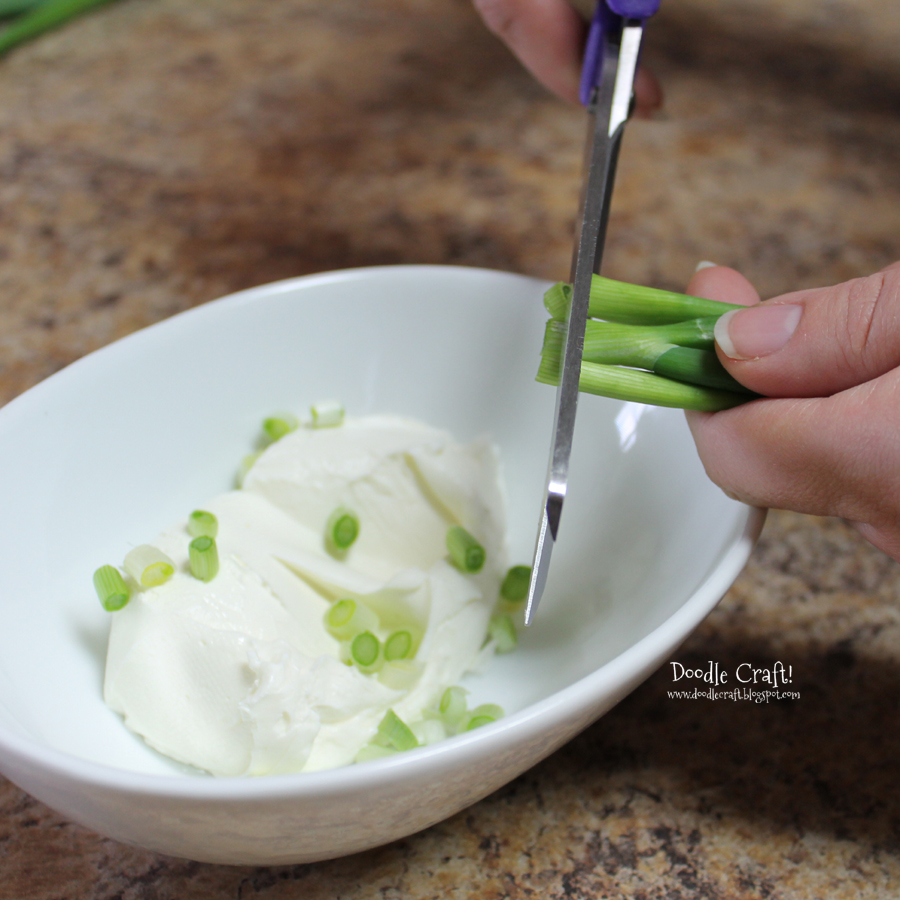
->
[706,263,900,397]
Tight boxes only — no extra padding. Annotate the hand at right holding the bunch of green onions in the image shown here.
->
[688,263,900,561]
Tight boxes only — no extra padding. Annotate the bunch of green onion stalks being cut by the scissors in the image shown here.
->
[537,275,757,412]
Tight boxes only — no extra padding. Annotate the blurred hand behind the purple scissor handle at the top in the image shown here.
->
[473,0,662,117]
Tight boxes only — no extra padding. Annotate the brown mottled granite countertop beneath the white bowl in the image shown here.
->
[0,0,900,900]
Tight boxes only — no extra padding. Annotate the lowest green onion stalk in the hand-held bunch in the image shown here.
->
[535,357,751,412]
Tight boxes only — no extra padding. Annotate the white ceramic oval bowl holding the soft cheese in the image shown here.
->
[0,266,763,864]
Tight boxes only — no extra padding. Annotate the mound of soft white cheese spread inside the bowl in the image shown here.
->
[104,416,506,775]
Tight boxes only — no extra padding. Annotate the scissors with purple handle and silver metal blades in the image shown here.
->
[525,0,660,625]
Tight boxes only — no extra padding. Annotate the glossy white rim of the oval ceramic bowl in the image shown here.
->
[0,264,767,803]
